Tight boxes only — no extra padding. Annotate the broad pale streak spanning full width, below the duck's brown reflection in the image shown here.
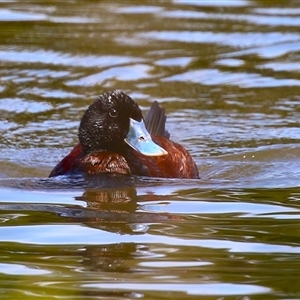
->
[0,225,300,253]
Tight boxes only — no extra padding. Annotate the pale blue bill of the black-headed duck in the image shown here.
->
[124,118,168,156]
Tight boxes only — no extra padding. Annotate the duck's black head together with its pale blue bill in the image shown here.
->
[79,90,167,156]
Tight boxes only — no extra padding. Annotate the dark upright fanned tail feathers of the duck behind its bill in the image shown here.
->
[144,101,170,139]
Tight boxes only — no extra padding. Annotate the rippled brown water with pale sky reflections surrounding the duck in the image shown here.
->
[0,0,300,300]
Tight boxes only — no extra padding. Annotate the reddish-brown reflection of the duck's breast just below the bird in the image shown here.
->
[75,175,179,234]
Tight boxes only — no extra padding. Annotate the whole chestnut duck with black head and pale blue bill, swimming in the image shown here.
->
[49,90,199,179]
